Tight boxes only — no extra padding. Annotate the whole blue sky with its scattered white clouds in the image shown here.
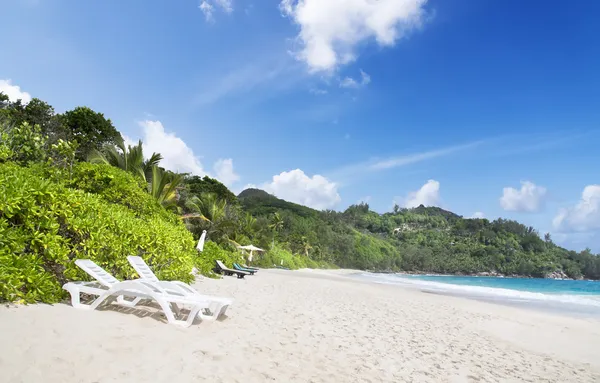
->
[0,0,600,251]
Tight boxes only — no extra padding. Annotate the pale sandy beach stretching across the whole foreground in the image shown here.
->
[0,270,600,382]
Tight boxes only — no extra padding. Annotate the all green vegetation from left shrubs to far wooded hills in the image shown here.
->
[0,93,600,302]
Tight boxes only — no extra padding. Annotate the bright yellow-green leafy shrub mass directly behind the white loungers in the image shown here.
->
[0,163,196,303]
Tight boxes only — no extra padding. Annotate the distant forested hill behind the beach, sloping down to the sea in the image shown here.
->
[238,189,600,279]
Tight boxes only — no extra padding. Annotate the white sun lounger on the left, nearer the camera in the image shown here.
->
[63,259,210,327]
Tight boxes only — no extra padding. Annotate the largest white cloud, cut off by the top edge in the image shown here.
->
[279,0,427,72]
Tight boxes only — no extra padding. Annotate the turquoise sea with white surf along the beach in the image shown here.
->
[357,273,600,317]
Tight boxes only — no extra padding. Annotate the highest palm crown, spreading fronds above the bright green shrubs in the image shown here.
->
[88,139,163,181]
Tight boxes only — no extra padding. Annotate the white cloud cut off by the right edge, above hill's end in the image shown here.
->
[552,185,600,232]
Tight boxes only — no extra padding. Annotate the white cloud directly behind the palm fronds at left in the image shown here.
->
[138,120,207,176]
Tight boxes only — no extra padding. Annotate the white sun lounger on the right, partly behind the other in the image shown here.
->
[127,255,233,319]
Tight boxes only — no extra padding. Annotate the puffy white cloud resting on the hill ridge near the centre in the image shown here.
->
[262,169,341,210]
